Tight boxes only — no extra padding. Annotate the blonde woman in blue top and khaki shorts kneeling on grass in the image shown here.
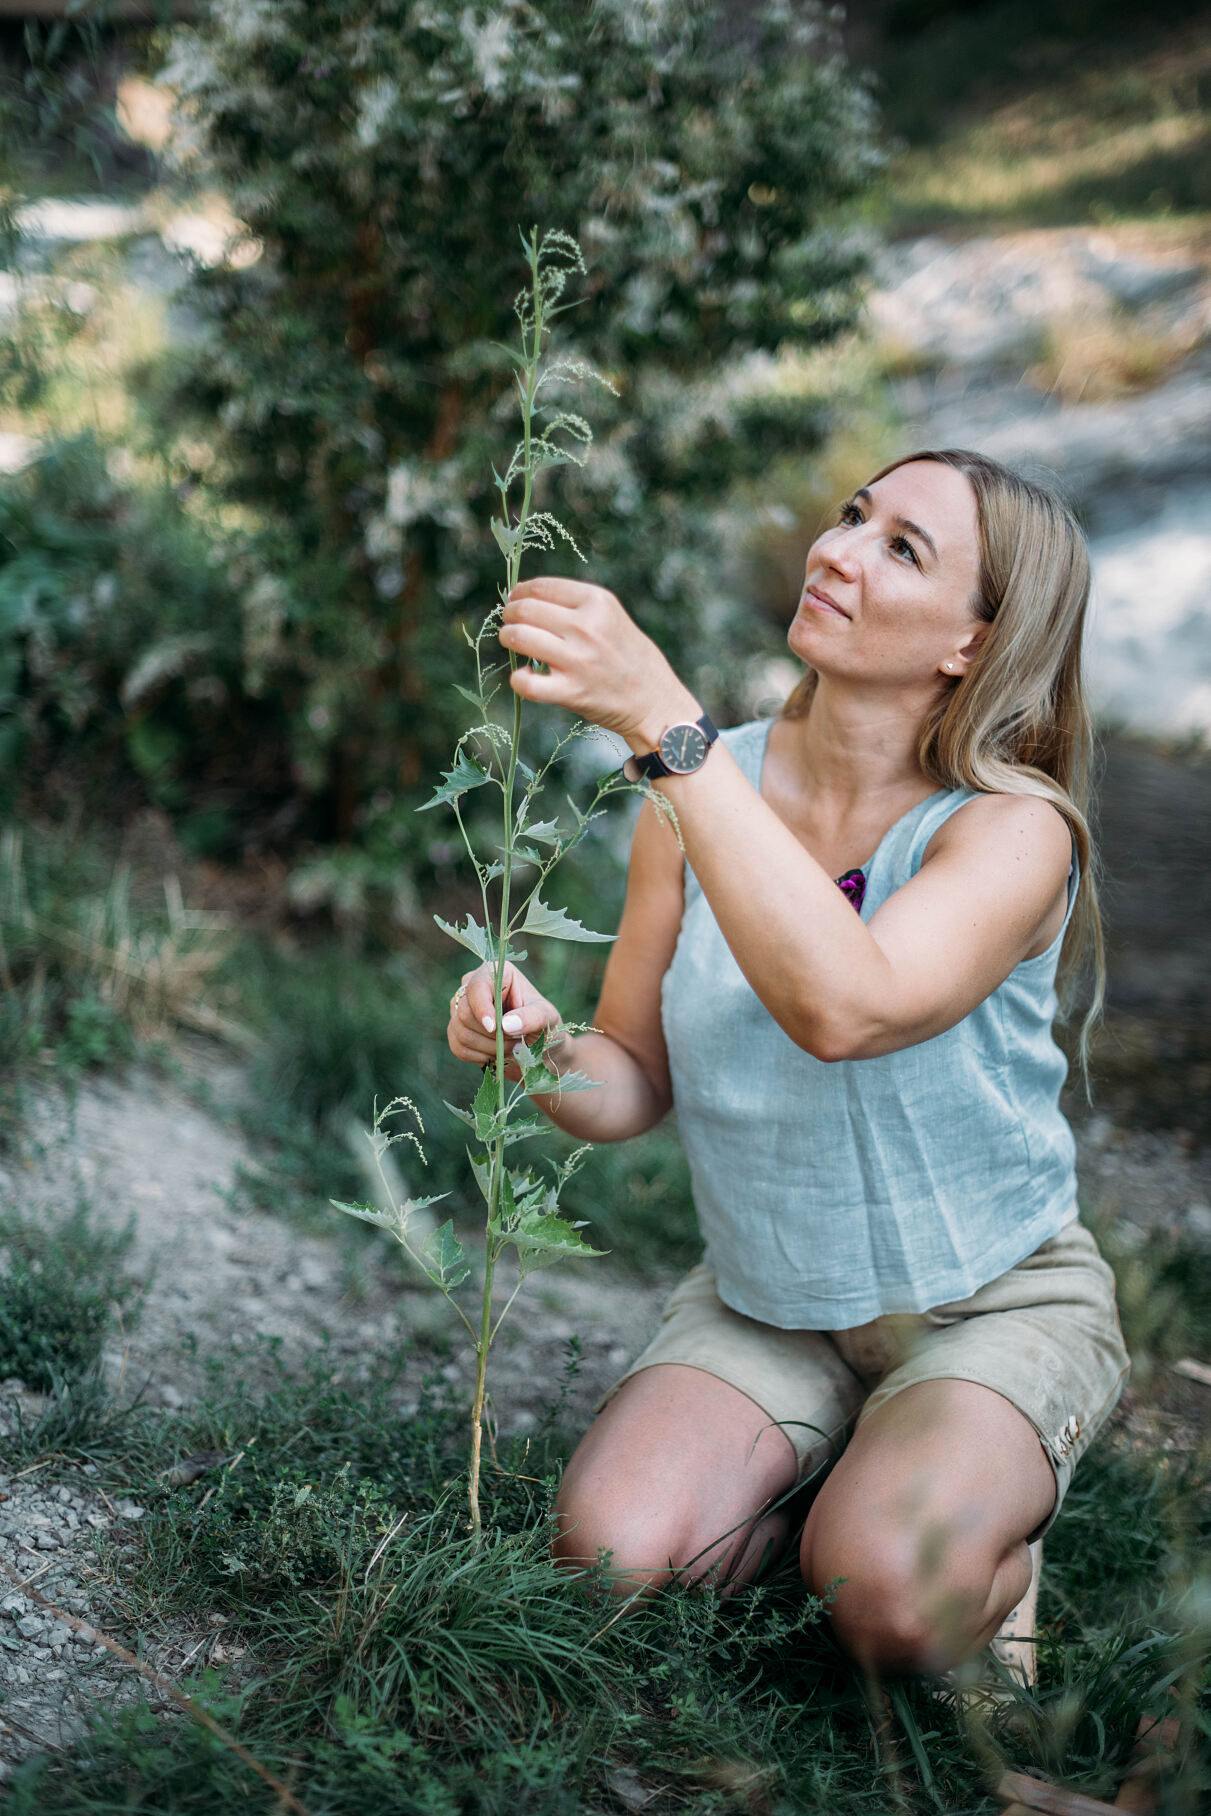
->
[448,450,1127,1671]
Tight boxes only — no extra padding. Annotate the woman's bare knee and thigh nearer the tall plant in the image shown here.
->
[554,1362,797,1594]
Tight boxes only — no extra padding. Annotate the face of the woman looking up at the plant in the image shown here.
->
[786,459,984,686]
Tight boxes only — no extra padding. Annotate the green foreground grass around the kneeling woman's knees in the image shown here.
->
[9,1205,1211,1816]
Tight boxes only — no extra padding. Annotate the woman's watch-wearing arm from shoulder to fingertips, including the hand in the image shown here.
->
[499,579,1069,1061]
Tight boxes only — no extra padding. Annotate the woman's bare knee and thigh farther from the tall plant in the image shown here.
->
[801,1380,1055,1671]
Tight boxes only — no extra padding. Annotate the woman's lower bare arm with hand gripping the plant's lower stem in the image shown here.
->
[447,806,683,1140]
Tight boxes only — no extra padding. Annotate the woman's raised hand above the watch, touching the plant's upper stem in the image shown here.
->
[499,579,701,752]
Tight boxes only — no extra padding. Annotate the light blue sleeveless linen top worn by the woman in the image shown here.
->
[661,721,1077,1331]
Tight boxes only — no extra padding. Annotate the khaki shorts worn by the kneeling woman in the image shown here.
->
[601,1222,1131,1536]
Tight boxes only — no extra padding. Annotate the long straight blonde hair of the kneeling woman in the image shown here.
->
[783,449,1106,1060]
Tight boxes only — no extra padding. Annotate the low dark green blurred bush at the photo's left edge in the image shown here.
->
[0,436,263,843]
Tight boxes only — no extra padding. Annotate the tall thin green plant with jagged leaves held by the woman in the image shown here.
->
[332,229,648,1533]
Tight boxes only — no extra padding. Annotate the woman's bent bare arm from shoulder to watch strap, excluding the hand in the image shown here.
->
[642,730,1071,1061]
